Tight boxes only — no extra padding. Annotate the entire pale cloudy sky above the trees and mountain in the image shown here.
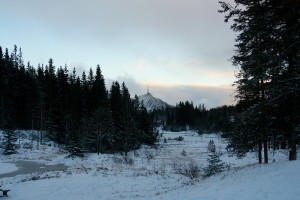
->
[0,0,237,108]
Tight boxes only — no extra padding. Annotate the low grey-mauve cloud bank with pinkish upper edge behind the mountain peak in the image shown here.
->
[106,75,235,108]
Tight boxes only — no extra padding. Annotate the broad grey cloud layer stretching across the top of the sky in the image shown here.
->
[0,0,233,51]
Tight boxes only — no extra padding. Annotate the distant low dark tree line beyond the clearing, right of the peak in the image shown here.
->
[152,101,235,134]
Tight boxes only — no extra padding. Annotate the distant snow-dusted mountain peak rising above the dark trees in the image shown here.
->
[139,93,172,111]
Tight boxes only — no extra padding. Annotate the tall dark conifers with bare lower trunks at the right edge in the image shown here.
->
[220,0,300,163]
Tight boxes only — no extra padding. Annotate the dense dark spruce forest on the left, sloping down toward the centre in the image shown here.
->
[0,45,157,155]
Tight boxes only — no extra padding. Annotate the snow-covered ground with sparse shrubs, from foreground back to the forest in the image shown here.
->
[0,132,300,200]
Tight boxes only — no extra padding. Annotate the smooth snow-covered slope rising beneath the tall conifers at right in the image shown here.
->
[153,161,300,200]
